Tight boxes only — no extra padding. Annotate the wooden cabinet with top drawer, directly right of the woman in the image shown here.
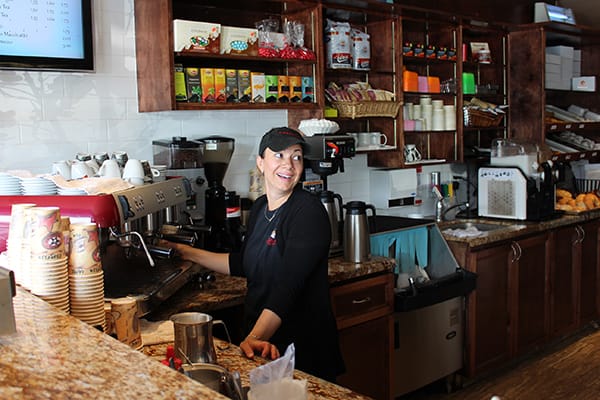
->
[331,273,394,399]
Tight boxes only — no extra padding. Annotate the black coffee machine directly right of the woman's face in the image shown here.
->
[302,134,356,257]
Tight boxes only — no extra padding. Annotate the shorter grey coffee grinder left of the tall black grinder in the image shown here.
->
[152,136,205,224]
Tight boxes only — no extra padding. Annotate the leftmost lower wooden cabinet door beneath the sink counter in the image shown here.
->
[467,244,513,376]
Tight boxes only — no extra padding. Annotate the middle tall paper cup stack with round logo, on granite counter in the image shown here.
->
[22,207,69,313]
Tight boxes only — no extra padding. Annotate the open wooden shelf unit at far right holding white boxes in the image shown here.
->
[508,23,600,160]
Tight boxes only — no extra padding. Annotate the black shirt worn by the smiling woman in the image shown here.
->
[229,188,344,381]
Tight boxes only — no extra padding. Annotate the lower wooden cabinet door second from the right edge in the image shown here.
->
[549,226,581,337]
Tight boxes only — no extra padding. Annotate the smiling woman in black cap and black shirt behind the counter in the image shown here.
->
[164,128,344,381]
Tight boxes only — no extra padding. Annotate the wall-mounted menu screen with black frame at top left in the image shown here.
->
[0,0,94,72]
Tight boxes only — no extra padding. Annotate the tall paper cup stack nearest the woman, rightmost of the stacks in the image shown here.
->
[69,223,106,330]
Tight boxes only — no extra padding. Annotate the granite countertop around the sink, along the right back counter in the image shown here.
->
[438,210,600,248]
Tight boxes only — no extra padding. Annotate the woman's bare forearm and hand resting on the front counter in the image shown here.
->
[240,309,281,360]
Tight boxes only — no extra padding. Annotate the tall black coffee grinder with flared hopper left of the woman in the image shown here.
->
[196,136,235,252]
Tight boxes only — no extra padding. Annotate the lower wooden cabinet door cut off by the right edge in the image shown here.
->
[579,221,600,326]
